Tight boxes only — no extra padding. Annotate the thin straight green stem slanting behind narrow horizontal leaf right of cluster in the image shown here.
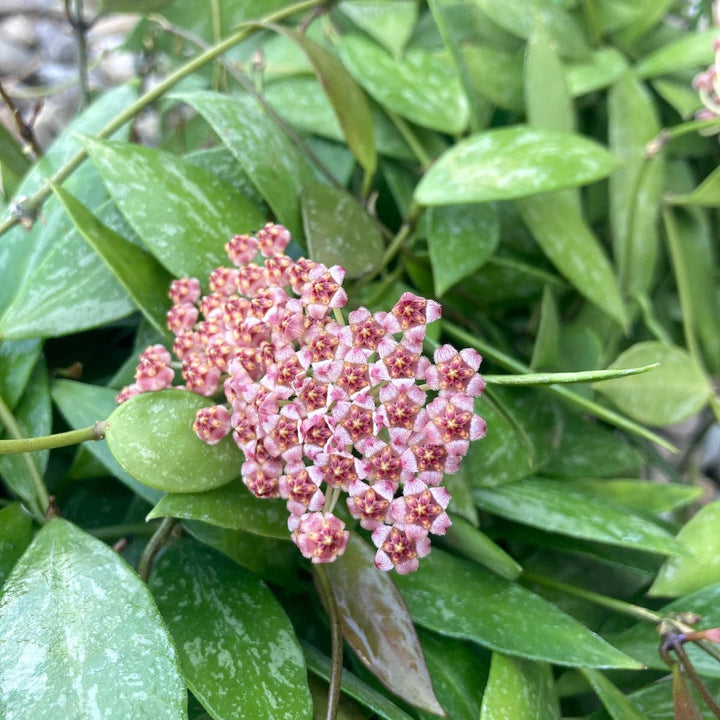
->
[443,321,677,452]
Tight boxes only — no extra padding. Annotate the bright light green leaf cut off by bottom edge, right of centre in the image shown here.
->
[480,652,560,720]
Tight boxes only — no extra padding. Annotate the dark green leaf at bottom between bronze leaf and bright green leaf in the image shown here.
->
[418,628,490,720]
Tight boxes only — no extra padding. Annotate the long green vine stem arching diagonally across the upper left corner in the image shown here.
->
[0,0,325,235]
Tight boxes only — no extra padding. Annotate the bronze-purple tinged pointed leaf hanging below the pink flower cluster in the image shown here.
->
[323,535,444,715]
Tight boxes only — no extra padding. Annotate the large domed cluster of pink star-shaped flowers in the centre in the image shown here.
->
[118,224,485,573]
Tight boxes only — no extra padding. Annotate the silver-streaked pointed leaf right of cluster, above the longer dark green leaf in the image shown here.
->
[473,478,683,555]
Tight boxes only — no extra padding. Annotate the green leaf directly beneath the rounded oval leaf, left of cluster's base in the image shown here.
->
[147,480,290,540]
